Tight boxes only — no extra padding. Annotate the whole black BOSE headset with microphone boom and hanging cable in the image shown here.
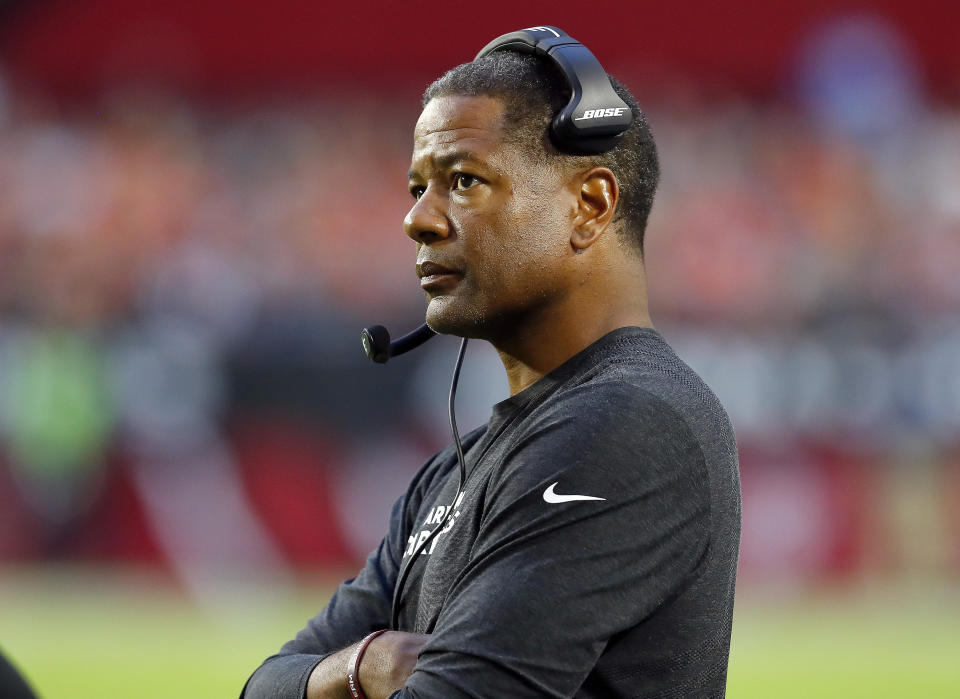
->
[360,26,633,629]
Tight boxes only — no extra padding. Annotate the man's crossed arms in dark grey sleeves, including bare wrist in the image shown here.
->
[244,392,709,699]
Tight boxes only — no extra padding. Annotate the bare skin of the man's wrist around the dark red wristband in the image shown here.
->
[307,631,430,699]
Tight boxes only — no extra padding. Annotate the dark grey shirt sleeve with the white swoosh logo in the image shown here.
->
[393,384,710,699]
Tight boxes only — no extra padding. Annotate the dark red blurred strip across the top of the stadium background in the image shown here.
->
[3,0,960,96]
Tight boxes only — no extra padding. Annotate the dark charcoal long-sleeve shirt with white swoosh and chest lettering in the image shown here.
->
[244,328,740,699]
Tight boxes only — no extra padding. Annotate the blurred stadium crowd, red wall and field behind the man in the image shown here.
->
[0,0,960,699]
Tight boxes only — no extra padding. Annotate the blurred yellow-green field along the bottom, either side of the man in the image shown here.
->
[0,568,960,699]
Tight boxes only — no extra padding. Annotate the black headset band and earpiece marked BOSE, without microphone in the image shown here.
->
[474,26,633,154]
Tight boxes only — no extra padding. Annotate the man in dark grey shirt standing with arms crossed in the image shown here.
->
[245,39,740,699]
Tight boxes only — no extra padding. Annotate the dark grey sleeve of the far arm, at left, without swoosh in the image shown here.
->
[240,455,450,699]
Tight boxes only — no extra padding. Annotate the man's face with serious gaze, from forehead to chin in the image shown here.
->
[404,96,576,340]
